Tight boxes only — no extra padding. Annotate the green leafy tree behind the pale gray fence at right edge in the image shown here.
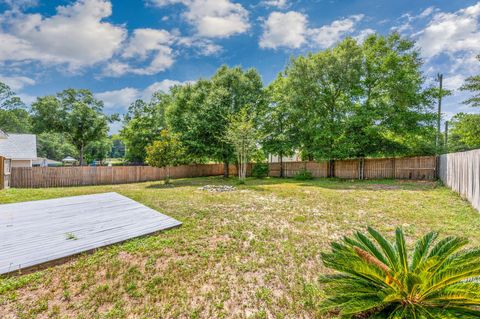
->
[447,113,480,152]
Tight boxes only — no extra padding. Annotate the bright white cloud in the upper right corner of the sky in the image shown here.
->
[417,2,480,58]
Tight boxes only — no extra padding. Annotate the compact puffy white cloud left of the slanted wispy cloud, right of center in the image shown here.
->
[260,11,308,49]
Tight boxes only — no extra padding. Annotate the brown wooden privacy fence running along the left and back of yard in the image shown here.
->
[11,156,436,188]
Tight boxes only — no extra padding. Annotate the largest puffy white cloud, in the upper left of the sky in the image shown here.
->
[0,0,126,70]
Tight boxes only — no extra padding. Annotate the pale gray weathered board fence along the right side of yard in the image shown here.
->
[438,149,480,211]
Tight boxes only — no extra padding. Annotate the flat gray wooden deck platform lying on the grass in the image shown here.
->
[0,193,181,274]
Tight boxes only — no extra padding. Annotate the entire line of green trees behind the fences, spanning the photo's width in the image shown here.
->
[0,34,480,168]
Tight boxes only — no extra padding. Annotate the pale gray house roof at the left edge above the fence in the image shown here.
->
[0,134,37,160]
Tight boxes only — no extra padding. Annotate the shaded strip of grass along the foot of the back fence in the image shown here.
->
[146,176,440,191]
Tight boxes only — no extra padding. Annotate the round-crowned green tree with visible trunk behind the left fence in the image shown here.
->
[32,89,115,165]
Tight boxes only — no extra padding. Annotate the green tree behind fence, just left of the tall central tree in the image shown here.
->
[120,92,170,163]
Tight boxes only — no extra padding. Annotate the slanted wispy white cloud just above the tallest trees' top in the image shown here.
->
[309,14,364,48]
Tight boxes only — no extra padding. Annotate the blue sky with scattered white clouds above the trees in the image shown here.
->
[0,0,480,131]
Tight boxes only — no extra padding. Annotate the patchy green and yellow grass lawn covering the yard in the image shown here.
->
[0,178,480,318]
